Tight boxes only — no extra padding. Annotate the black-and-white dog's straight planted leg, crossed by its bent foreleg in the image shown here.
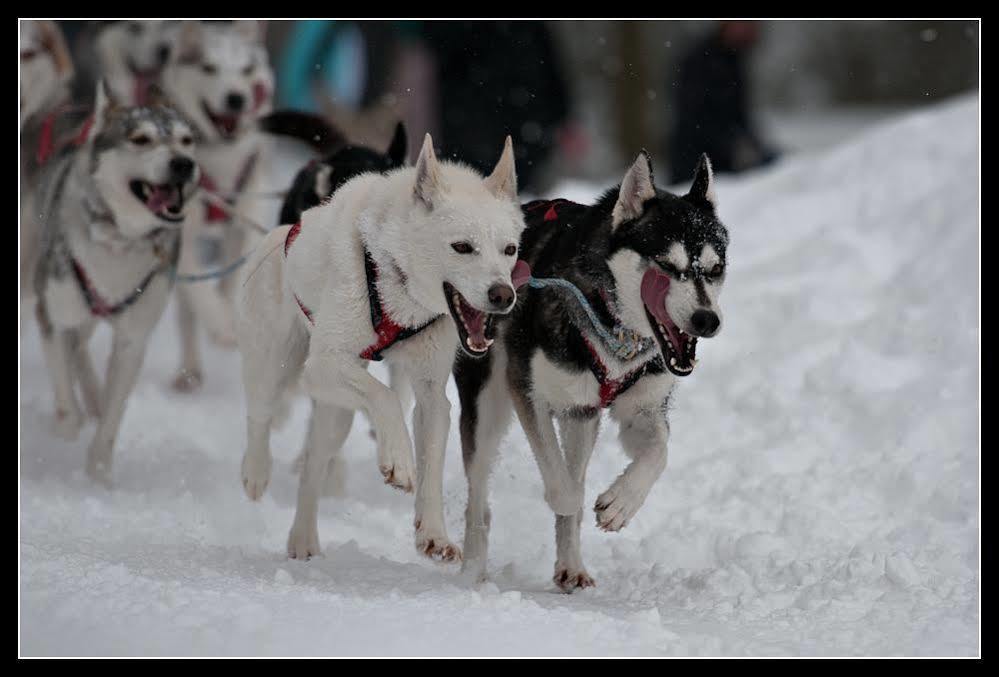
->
[552,412,600,592]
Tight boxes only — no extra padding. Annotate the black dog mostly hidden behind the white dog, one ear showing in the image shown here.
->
[280,122,406,224]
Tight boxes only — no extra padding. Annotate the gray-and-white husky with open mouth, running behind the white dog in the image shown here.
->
[35,84,199,484]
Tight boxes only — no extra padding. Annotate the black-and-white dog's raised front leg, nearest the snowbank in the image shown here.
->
[594,403,669,531]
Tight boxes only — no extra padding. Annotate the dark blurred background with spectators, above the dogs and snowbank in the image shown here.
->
[258,21,979,193]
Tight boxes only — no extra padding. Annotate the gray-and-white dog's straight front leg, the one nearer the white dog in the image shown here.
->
[87,328,149,486]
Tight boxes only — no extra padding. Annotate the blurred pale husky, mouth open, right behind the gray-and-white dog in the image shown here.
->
[163,21,274,390]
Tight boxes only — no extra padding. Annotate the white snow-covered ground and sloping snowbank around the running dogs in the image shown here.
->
[20,97,980,655]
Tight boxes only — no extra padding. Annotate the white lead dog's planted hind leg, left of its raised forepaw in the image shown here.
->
[288,400,354,559]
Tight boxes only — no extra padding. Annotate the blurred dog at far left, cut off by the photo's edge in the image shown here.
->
[19,20,76,300]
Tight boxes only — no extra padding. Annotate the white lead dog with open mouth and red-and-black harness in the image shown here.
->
[238,134,524,561]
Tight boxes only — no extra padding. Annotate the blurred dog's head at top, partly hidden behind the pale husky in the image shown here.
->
[75,20,180,106]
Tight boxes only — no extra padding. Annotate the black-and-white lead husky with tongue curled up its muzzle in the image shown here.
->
[454,153,728,592]
